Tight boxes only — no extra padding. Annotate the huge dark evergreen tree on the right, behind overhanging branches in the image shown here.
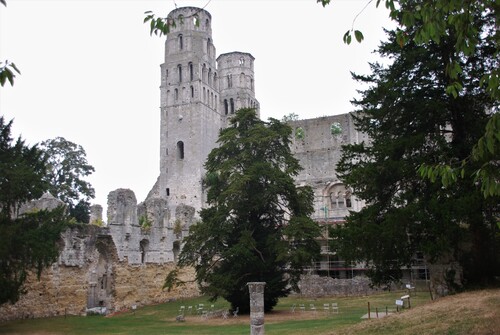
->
[332,6,500,291]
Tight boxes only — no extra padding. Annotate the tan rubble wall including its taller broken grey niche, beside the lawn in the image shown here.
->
[0,220,199,321]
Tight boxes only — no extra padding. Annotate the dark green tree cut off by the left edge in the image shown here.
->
[0,117,68,304]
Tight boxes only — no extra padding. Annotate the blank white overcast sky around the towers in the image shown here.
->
[0,0,391,220]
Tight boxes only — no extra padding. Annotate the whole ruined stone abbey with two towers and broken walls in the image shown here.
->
[0,7,392,320]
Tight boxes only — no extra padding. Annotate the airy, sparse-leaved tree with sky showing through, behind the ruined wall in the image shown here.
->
[41,137,95,223]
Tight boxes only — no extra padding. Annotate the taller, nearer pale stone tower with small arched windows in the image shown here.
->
[158,7,222,218]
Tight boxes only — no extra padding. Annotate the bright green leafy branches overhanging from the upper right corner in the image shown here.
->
[317,0,500,197]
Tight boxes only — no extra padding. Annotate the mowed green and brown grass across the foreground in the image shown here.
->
[0,289,500,335]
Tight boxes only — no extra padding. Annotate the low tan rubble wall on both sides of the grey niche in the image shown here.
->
[0,262,199,321]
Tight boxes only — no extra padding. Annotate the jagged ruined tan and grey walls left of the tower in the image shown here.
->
[0,189,199,320]
